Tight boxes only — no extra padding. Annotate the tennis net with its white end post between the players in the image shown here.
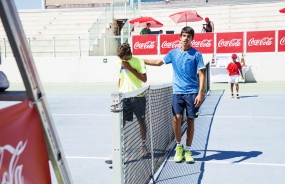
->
[111,64,210,184]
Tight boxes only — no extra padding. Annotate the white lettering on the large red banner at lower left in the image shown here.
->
[0,141,28,184]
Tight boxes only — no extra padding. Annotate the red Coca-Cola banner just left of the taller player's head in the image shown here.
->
[160,34,181,54]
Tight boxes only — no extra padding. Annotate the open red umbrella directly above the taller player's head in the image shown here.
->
[169,10,203,26]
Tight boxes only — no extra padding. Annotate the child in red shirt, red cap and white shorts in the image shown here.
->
[227,54,243,98]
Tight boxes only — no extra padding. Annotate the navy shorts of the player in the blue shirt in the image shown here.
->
[172,93,199,118]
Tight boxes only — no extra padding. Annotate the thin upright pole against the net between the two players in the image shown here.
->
[148,89,154,182]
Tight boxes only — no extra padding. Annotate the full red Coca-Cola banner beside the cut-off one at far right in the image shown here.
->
[246,31,275,52]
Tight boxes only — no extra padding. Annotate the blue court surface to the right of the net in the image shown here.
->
[154,91,285,184]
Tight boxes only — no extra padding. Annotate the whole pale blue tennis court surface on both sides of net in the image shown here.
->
[1,82,285,184]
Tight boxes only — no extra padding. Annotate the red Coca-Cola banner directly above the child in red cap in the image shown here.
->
[217,32,243,53]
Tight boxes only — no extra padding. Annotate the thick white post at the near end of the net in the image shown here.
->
[111,93,124,184]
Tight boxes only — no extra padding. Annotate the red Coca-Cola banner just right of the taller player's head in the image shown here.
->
[191,33,214,54]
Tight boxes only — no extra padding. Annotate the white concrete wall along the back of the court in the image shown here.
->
[0,53,285,83]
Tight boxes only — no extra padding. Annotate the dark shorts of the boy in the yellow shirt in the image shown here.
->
[123,97,146,121]
